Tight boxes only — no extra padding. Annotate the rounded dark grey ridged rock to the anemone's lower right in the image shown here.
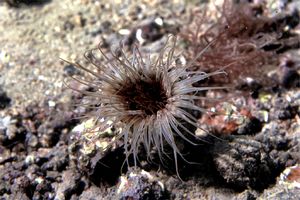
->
[213,137,278,190]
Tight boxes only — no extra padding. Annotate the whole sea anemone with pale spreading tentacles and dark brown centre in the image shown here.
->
[67,36,224,177]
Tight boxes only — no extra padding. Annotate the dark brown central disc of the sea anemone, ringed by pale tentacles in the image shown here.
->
[118,78,167,115]
